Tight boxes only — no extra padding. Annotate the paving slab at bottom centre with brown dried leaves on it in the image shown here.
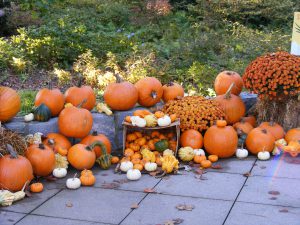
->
[121,194,233,225]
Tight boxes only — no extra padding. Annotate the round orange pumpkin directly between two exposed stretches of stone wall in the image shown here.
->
[58,106,93,138]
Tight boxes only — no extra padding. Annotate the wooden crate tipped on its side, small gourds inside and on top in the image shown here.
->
[122,119,180,156]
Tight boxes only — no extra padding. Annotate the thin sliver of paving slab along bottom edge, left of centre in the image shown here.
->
[15,215,109,225]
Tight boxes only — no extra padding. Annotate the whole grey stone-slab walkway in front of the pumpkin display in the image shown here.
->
[0,156,300,225]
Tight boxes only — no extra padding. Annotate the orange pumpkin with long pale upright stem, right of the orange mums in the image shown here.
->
[215,84,246,124]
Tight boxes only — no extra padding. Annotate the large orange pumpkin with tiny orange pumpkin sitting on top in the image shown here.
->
[204,121,238,158]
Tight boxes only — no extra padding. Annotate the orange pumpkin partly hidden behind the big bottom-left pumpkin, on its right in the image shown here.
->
[25,144,55,176]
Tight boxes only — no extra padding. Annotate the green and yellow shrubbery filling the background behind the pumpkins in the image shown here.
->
[0,0,300,94]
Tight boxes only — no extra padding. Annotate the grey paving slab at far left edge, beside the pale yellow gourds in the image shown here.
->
[0,189,60,214]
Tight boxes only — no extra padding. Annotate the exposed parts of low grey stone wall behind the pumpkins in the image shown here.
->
[5,93,256,153]
